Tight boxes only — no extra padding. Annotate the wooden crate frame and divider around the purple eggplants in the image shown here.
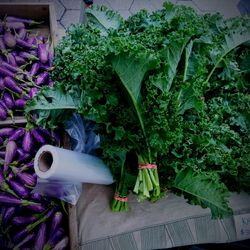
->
[0,2,78,250]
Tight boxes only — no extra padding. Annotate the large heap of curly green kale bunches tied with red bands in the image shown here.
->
[25,3,250,218]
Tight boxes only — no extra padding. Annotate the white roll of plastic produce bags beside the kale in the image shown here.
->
[34,145,113,185]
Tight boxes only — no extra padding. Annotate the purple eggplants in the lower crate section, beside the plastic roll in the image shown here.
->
[0,123,68,249]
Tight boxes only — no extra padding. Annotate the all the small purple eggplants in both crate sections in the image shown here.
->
[0,16,69,250]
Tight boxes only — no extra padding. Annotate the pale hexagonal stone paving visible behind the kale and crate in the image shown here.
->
[3,0,250,39]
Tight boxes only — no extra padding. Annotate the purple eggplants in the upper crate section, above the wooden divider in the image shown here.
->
[0,16,53,121]
